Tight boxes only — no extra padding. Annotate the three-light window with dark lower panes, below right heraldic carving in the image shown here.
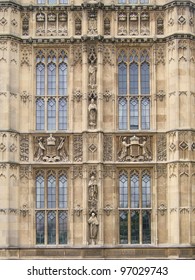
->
[119,170,152,244]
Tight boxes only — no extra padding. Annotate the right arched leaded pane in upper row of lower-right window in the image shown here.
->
[142,174,151,208]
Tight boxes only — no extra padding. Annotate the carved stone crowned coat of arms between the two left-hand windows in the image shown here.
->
[33,134,69,162]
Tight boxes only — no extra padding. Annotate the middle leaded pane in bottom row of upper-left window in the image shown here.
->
[47,98,56,130]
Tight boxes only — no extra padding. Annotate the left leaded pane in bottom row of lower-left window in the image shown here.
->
[36,212,45,244]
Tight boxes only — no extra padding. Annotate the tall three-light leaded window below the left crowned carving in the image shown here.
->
[35,170,68,245]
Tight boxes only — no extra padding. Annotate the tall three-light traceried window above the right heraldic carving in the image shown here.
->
[118,49,151,130]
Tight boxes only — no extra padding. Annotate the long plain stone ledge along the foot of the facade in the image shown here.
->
[0,246,195,259]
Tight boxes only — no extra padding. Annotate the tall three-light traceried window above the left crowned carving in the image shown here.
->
[36,50,68,131]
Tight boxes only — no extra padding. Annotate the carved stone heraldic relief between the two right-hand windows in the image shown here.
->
[117,135,152,162]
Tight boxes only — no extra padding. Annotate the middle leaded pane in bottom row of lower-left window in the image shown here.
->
[47,211,56,244]
